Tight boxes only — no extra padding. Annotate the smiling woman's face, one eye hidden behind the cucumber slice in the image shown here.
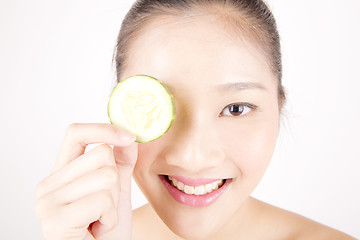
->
[122,15,279,238]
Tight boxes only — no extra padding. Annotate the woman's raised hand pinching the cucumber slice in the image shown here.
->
[35,124,137,240]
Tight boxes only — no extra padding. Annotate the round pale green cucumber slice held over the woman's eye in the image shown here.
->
[108,75,175,143]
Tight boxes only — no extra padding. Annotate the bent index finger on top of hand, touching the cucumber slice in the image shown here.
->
[53,123,136,172]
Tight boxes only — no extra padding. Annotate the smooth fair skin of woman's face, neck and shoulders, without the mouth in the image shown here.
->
[124,13,352,240]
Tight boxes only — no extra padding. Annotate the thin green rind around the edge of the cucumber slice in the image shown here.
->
[107,74,176,143]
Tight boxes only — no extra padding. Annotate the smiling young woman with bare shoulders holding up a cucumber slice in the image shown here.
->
[36,0,353,240]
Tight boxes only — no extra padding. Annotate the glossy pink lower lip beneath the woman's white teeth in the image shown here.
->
[159,175,231,207]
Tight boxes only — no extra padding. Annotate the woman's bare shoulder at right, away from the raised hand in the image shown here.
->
[250,199,356,240]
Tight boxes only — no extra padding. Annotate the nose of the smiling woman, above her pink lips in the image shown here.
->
[163,104,225,175]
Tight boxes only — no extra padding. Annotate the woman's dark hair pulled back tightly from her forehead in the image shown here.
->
[115,0,285,103]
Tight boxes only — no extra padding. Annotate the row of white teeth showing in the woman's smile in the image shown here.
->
[168,176,224,195]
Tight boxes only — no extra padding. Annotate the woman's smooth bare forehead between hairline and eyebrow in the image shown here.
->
[124,15,274,91]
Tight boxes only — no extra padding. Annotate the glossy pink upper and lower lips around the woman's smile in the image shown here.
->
[159,175,231,207]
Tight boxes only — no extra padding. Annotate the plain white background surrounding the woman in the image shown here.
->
[0,0,360,239]
